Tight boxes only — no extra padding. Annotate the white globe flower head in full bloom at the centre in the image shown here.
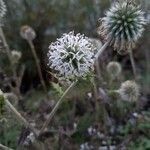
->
[48,32,96,81]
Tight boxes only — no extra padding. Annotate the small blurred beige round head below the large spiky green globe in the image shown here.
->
[106,61,122,79]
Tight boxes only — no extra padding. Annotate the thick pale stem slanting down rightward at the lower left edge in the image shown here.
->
[5,97,37,136]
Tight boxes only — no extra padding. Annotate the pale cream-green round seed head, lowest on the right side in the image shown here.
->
[118,80,140,102]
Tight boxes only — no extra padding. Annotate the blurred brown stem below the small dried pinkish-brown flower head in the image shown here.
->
[28,40,49,98]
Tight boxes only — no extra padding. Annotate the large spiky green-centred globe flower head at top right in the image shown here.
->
[98,0,146,53]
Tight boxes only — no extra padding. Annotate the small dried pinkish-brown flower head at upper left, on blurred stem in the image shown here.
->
[20,25,36,41]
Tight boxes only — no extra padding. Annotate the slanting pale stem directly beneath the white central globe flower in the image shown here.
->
[39,81,77,135]
